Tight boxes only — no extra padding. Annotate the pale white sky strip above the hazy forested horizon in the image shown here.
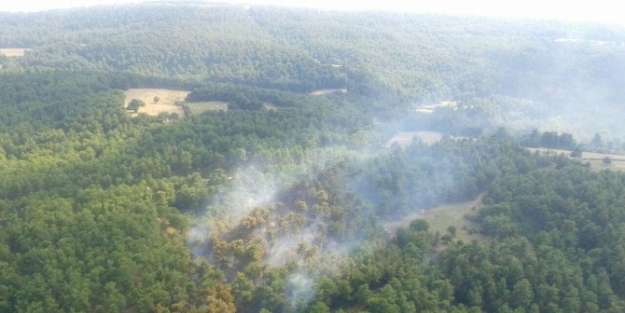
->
[0,0,622,23]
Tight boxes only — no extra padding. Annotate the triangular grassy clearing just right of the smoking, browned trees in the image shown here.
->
[384,192,488,242]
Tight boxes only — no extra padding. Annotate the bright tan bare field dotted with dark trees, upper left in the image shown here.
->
[124,88,189,117]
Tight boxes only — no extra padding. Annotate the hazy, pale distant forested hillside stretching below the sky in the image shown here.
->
[0,3,625,139]
